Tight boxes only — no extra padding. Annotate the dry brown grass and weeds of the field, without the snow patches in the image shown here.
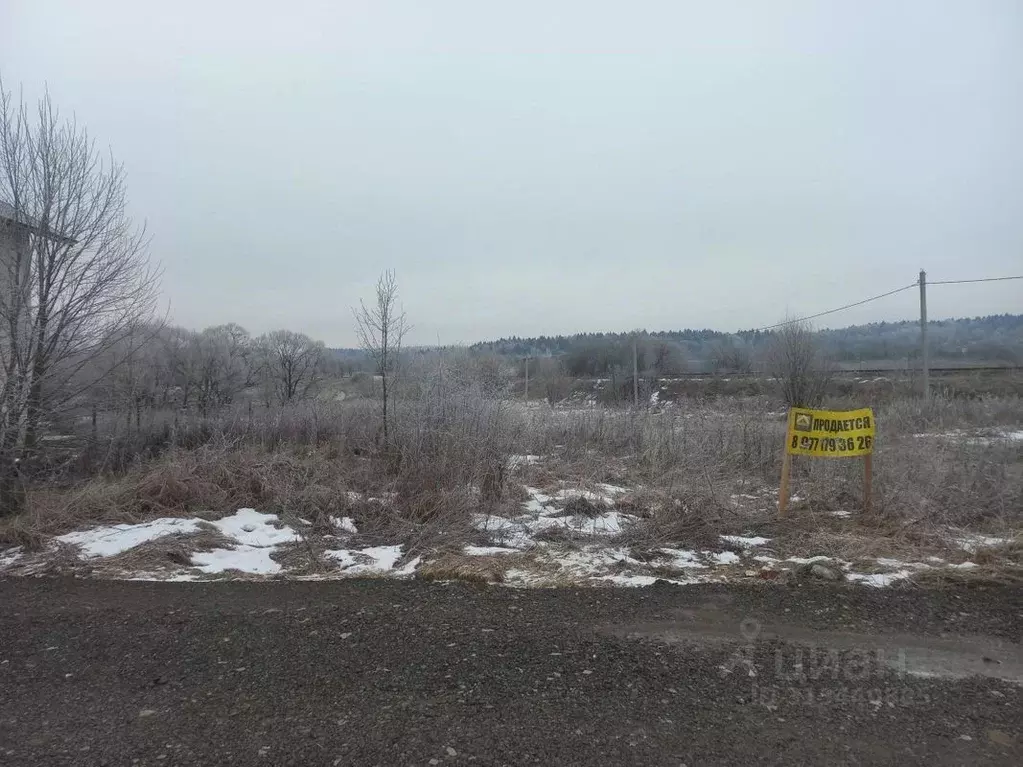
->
[0,375,1023,578]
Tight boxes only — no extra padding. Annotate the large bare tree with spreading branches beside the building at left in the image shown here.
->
[0,82,159,513]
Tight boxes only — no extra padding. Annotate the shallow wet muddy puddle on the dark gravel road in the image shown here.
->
[602,608,1023,685]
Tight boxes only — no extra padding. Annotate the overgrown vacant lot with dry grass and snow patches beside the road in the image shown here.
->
[0,377,1023,586]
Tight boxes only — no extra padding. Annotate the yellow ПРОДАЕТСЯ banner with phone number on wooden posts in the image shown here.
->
[786,407,875,458]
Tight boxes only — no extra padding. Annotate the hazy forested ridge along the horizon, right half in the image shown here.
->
[471,314,1023,375]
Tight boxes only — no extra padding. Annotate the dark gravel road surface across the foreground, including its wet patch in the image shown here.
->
[0,579,1023,767]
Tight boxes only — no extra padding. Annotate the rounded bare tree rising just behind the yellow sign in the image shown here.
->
[764,322,832,407]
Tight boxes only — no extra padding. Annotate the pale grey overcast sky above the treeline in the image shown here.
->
[0,0,1023,346]
